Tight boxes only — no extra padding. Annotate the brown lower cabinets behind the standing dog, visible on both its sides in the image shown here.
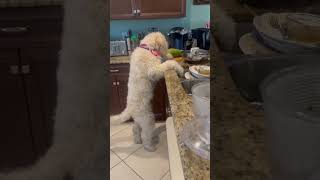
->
[110,64,167,121]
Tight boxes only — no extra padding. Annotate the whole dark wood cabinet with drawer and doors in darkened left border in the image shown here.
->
[0,6,63,171]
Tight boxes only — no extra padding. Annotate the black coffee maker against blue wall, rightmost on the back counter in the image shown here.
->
[191,28,210,50]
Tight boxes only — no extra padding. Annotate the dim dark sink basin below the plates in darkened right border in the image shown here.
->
[224,52,320,103]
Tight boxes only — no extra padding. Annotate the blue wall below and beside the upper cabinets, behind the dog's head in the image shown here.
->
[110,0,210,40]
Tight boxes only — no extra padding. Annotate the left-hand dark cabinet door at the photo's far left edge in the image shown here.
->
[0,50,34,171]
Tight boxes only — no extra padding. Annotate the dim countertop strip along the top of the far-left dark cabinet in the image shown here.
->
[0,0,64,7]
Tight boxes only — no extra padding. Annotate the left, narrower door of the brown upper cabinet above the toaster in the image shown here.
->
[110,0,136,19]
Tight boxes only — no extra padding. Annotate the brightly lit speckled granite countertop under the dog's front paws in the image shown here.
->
[165,70,210,180]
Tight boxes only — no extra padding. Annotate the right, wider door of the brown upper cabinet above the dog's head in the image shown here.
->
[136,0,186,18]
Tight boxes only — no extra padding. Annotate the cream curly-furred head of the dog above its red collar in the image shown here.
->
[141,32,169,57]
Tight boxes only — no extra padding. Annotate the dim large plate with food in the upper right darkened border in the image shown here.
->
[241,13,320,53]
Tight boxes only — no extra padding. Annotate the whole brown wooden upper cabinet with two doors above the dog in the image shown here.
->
[110,0,186,19]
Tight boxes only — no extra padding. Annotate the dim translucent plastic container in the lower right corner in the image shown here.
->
[260,62,320,180]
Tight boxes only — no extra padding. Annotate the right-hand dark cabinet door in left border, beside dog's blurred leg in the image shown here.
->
[21,46,60,157]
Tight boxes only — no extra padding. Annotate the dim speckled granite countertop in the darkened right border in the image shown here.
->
[211,39,270,180]
